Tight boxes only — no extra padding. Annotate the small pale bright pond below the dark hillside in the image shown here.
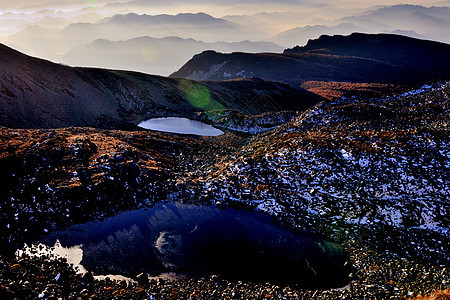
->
[138,118,223,136]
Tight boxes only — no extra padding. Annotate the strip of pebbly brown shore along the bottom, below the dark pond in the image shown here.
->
[0,243,449,299]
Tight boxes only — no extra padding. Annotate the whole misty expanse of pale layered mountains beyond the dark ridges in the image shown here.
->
[0,1,450,75]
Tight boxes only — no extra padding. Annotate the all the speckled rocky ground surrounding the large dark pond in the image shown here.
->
[0,83,450,299]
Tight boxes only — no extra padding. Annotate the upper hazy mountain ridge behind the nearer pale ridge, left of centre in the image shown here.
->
[8,13,267,61]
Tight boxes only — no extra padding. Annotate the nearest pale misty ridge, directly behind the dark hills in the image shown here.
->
[61,37,284,75]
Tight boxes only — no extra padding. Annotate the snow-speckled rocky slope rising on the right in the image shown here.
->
[192,83,450,265]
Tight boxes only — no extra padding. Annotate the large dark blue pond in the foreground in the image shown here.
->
[37,203,349,288]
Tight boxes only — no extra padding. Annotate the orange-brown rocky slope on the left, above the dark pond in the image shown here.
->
[0,128,202,250]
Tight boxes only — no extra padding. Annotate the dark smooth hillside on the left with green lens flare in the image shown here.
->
[0,45,322,128]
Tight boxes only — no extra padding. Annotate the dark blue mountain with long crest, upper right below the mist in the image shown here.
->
[171,33,450,85]
